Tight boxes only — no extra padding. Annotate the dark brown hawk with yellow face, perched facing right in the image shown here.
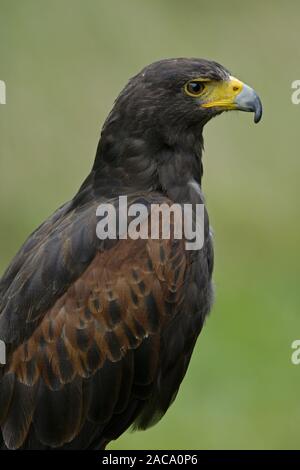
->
[0,58,262,449]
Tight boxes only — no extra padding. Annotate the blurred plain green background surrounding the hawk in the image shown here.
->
[0,0,300,449]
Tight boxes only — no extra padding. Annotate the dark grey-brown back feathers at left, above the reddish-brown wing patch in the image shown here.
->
[0,198,97,346]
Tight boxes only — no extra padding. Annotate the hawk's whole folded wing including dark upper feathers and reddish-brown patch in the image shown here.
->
[0,194,192,448]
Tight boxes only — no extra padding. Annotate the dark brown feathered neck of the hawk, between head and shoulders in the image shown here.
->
[78,126,203,203]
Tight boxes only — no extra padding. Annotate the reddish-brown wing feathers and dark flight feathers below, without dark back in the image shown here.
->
[2,233,186,448]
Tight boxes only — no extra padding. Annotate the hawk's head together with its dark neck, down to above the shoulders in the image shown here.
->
[93,58,262,187]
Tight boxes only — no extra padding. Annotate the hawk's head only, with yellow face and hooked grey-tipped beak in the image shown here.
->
[108,58,262,144]
